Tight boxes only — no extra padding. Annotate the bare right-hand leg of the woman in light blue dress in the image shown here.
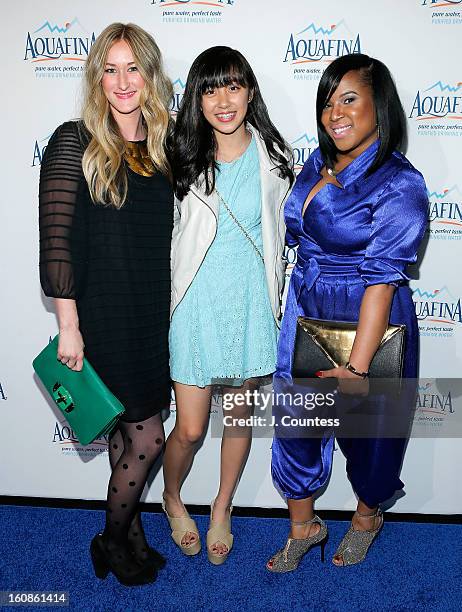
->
[210,380,255,555]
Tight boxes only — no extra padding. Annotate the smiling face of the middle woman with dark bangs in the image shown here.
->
[201,83,250,137]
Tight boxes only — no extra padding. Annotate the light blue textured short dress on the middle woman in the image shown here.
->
[170,138,277,387]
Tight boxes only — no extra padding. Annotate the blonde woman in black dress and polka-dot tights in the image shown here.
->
[40,23,173,585]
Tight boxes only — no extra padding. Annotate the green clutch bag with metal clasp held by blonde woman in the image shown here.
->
[32,336,125,444]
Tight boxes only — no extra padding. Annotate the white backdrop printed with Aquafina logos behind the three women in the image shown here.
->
[0,0,462,513]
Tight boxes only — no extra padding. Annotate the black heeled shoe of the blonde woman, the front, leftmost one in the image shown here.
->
[90,533,157,586]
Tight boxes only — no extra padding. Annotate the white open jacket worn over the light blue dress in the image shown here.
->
[170,124,290,325]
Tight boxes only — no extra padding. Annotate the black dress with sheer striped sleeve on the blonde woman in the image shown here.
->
[39,122,173,422]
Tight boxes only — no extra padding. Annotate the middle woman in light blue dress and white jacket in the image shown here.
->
[164,47,293,565]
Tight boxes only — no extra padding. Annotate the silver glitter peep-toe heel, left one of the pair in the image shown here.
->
[266,514,327,573]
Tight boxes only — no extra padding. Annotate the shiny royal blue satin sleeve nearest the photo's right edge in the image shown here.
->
[358,165,428,286]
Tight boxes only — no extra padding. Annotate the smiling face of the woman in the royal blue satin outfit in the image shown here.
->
[321,70,377,158]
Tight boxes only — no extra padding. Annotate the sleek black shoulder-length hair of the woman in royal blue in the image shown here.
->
[316,53,406,175]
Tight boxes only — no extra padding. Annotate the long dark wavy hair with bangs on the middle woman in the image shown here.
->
[172,46,294,200]
